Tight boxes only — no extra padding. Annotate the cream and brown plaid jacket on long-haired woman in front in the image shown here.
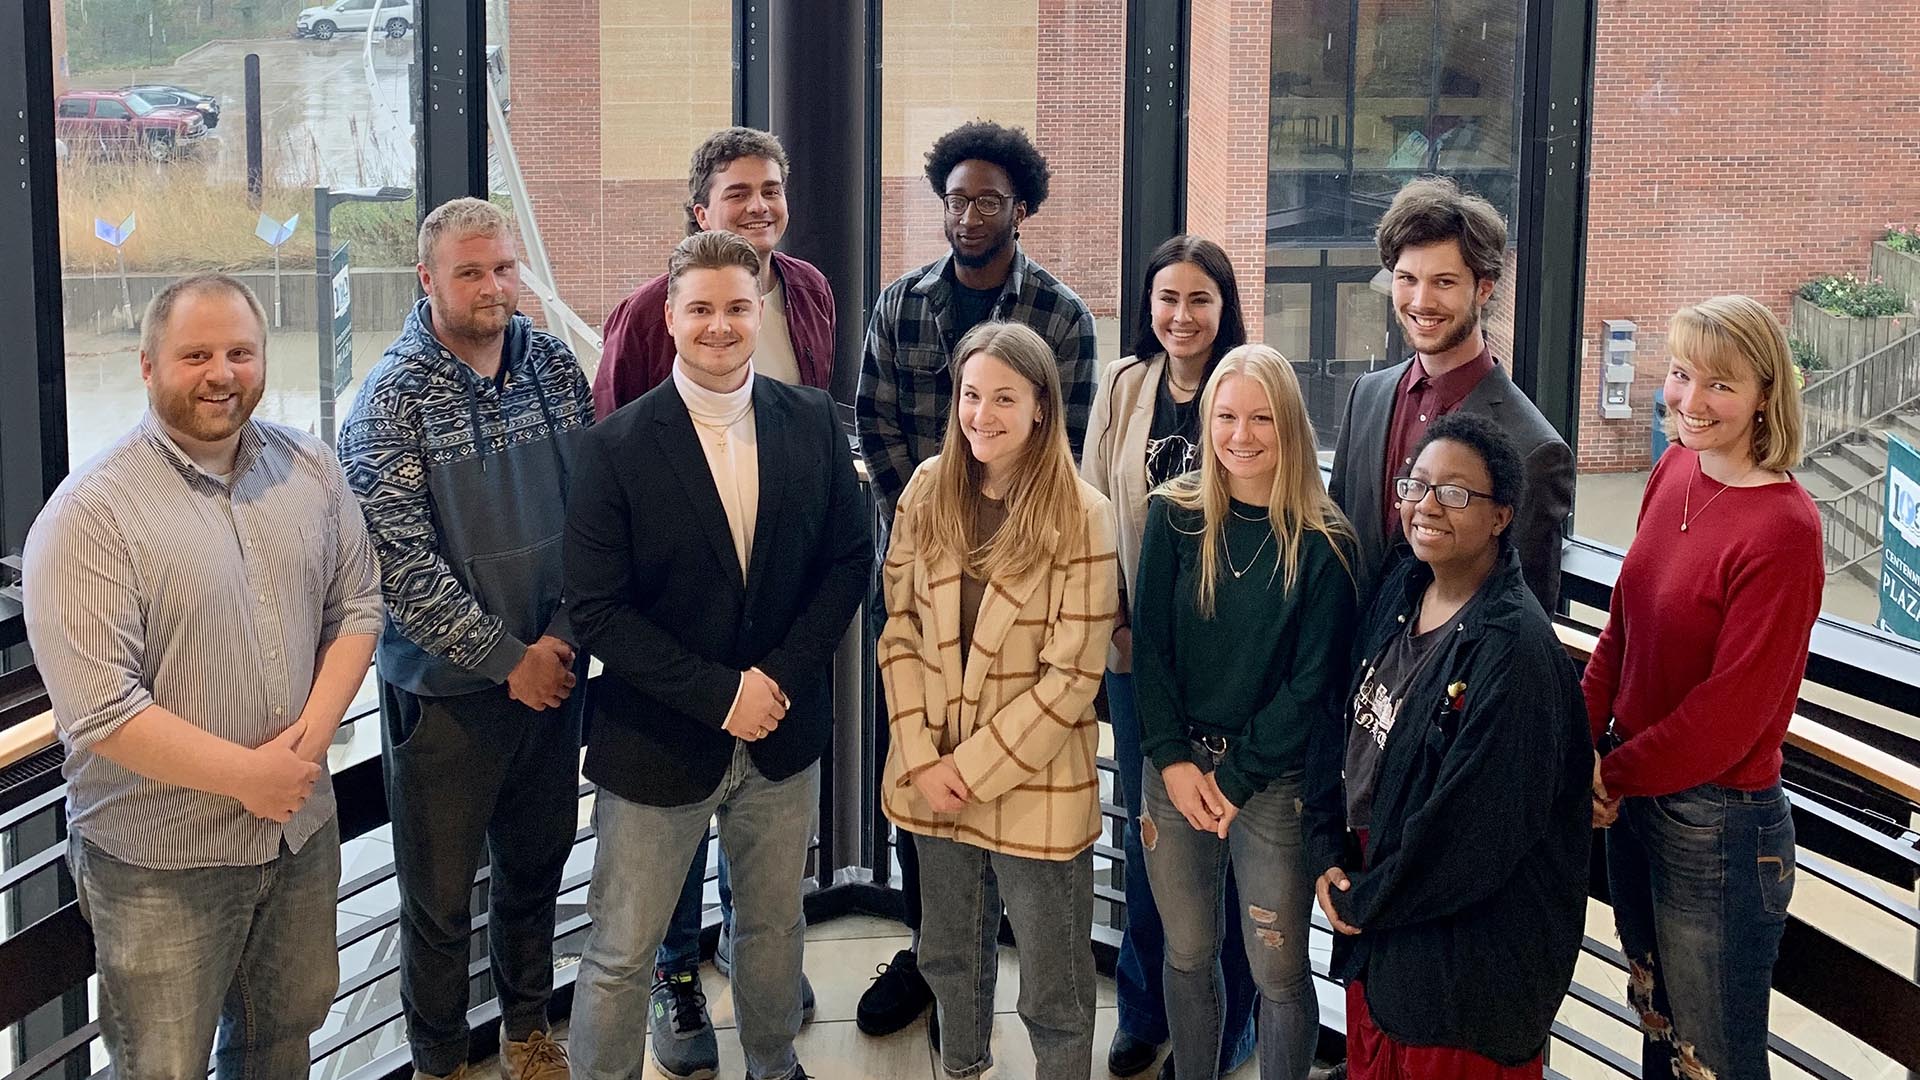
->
[877,457,1119,861]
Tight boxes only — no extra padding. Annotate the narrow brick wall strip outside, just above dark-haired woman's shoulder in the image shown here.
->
[1187,0,1273,340]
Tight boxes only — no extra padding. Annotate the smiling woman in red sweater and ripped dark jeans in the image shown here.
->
[1582,296,1826,1080]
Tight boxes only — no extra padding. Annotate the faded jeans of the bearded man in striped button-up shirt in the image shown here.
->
[67,819,340,1080]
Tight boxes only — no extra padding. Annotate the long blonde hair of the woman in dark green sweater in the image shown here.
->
[1154,344,1354,619]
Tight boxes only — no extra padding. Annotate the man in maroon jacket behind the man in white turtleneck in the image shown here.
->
[593,127,833,1078]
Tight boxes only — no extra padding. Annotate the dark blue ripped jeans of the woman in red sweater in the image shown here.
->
[1607,772,1793,1080]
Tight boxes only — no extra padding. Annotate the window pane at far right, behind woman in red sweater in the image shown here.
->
[1574,4,1920,636]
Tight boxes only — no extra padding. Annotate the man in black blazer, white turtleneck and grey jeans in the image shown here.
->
[566,233,872,1080]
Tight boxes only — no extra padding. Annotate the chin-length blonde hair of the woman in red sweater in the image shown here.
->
[1667,296,1805,473]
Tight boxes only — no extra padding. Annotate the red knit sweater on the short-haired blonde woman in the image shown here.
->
[1582,446,1826,796]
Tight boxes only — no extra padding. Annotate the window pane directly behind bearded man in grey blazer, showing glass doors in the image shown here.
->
[1187,0,1524,448]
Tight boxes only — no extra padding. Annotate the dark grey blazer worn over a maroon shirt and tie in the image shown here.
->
[1329,357,1574,611]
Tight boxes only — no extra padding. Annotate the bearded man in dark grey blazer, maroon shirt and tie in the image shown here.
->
[1331,177,1574,613]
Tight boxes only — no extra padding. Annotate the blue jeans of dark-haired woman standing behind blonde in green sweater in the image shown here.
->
[1106,671,1260,1072]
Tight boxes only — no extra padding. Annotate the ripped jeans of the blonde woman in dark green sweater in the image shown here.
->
[1142,751,1319,1080]
